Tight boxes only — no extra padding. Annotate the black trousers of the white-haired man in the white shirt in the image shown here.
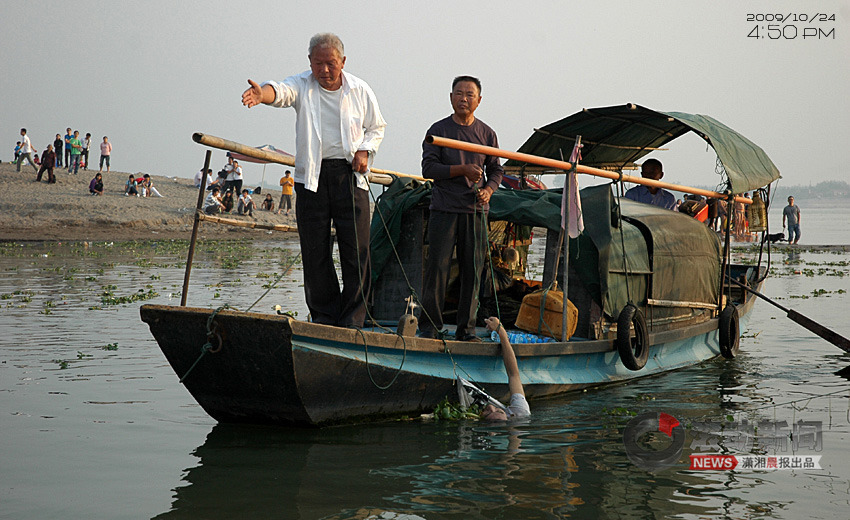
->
[295,159,372,327]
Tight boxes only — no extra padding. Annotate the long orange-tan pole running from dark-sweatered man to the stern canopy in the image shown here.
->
[425,135,753,204]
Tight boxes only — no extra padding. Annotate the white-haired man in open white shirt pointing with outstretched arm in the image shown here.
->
[242,33,386,327]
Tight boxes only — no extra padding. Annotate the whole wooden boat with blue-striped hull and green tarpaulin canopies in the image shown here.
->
[141,105,778,425]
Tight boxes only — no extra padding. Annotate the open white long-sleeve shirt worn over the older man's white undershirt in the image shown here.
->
[263,70,387,192]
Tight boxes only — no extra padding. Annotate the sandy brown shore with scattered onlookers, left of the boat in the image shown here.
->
[0,163,295,240]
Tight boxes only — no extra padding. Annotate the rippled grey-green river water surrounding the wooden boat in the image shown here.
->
[0,216,850,519]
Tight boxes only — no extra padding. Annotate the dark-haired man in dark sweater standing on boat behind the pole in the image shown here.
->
[419,76,504,341]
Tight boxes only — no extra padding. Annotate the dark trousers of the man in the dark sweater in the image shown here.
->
[419,210,487,338]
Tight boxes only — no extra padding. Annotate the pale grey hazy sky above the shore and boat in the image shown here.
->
[0,0,850,192]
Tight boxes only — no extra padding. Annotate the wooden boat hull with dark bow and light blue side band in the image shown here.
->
[141,284,753,426]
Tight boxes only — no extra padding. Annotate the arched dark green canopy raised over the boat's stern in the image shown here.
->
[505,104,779,194]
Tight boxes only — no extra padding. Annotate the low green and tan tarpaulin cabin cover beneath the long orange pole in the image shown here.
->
[371,178,721,317]
